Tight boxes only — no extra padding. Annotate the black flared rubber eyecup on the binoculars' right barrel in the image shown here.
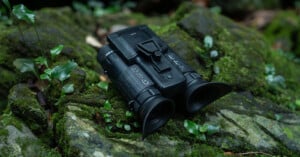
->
[186,82,231,113]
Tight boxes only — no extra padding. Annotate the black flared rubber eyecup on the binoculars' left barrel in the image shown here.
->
[142,96,175,137]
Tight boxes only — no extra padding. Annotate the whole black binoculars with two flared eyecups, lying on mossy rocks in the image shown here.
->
[97,25,231,137]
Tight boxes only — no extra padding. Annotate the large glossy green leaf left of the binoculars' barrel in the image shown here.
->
[49,61,77,82]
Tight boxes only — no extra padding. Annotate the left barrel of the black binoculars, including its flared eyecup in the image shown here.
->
[98,45,175,136]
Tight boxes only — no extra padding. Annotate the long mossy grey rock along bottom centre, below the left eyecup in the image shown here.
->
[56,97,225,156]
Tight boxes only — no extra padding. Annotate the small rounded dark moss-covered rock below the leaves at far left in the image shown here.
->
[8,84,48,133]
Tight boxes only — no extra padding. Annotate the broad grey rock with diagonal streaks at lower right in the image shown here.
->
[204,93,300,155]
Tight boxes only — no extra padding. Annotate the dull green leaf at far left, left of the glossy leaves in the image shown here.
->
[13,58,36,73]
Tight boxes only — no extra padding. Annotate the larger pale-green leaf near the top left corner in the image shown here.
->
[12,4,35,24]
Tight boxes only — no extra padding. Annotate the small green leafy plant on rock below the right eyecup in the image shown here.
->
[184,120,220,141]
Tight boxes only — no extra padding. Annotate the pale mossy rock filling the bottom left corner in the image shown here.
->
[0,113,61,157]
